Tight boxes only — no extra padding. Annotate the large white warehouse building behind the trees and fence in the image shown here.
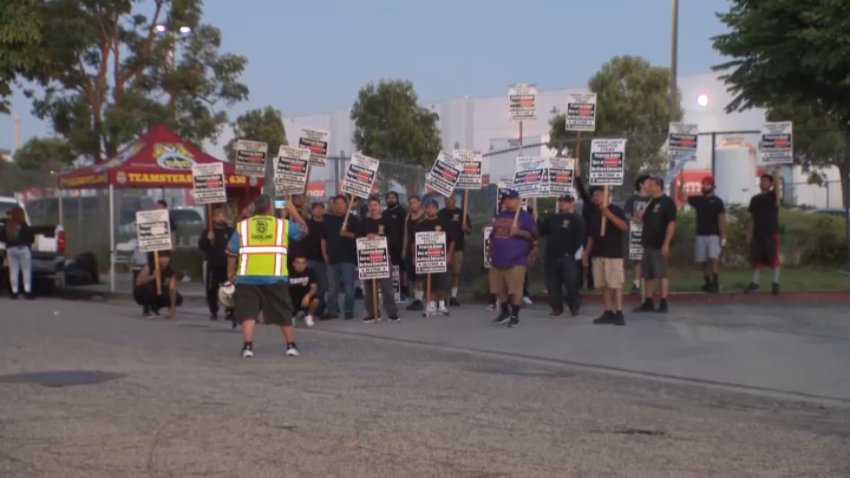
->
[284,73,841,207]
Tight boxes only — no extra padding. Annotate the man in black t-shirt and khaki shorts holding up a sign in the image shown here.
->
[581,186,629,325]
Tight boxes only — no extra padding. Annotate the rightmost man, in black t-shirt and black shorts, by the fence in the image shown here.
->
[745,174,781,295]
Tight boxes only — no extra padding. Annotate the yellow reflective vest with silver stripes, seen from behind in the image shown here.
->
[237,216,289,276]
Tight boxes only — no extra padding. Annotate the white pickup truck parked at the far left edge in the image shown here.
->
[0,196,65,294]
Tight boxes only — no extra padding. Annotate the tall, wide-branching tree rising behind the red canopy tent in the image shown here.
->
[24,0,248,161]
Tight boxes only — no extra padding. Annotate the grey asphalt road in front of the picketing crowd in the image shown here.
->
[0,299,850,477]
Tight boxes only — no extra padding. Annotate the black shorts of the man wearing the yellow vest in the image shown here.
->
[234,282,293,326]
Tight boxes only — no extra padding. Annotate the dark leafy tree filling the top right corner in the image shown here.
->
[713,0,850,209]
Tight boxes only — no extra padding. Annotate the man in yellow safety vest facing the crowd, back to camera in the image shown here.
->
[227,194,308,358]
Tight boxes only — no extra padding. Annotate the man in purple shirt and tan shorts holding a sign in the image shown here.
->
[490,189,537,327]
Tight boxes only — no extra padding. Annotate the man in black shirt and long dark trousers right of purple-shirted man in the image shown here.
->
[538,195,585,318]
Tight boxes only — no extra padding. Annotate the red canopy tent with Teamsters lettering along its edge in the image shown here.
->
[59,124,263,292]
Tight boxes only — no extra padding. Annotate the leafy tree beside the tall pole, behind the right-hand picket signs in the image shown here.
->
[549,56,682,182]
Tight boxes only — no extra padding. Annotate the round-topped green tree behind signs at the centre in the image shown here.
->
[351,80,442,166]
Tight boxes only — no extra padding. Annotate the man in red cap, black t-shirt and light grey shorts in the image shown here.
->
[680,176,726,292]
